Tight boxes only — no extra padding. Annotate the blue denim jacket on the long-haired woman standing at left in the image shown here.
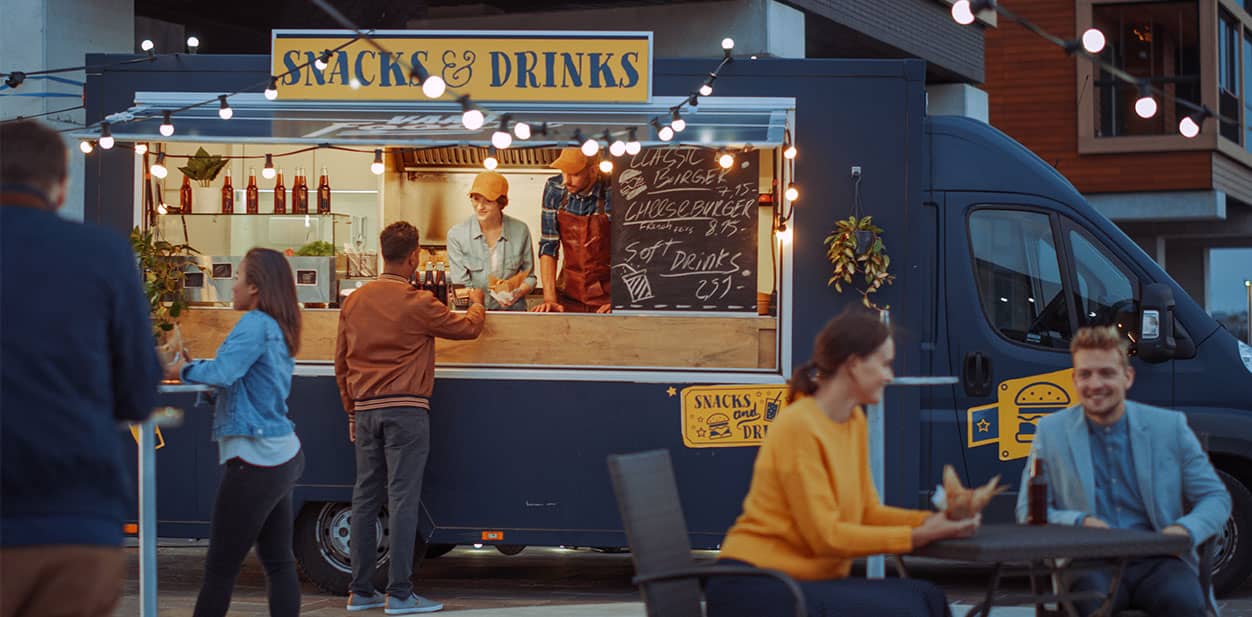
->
[182,310,295,441]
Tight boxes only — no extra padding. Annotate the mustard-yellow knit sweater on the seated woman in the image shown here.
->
[721,398,930,581]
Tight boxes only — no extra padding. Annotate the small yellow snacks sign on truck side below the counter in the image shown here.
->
[682,384,786,448]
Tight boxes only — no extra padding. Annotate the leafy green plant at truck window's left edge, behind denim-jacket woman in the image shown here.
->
[130,228,199,364]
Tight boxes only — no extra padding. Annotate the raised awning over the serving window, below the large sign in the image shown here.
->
[83,93,795,148]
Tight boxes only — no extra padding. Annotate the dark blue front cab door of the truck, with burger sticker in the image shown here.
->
[931,193,1173,521]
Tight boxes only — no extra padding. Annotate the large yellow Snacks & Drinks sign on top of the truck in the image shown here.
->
[270,30,652,103]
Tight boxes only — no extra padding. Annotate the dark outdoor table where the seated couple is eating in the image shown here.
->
[910,524,1191,617]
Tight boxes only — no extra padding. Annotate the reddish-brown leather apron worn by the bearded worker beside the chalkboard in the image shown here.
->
[556,195,612,313]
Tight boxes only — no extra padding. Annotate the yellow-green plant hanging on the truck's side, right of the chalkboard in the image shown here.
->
[825,214,895,310]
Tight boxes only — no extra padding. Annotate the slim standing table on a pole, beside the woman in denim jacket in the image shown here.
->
[139,383,213,617]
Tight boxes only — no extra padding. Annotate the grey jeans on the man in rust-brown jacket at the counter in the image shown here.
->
[352,407,431,598]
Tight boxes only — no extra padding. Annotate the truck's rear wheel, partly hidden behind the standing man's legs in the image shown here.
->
[293,503,391,596]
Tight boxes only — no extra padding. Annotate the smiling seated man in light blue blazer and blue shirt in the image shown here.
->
[1017,327,1231,617]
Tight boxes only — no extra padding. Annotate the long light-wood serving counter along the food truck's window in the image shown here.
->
[179,308,777,369]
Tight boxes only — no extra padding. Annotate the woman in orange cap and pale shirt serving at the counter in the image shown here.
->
[448,171,535,310]
